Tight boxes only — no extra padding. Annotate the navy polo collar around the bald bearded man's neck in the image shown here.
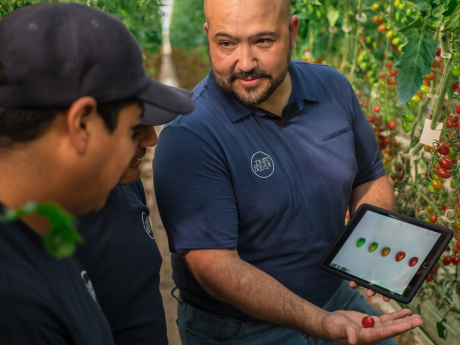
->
[208,61,319,122]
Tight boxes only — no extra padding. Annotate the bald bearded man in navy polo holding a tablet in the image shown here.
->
[154,0,422,345]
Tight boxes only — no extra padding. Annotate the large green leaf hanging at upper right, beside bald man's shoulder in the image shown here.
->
[396,35,436,106]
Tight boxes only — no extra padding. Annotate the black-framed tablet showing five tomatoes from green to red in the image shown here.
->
[320,204,453,304]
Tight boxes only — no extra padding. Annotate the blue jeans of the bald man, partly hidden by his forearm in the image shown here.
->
[173,281,397,345]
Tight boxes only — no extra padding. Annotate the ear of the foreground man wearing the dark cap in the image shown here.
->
[67,97,99,154]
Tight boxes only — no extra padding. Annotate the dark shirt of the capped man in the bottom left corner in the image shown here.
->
[0,204,114,345]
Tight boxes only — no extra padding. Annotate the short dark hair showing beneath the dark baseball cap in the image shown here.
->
[0,62,139,148]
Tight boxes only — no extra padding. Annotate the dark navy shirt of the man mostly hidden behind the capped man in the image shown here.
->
[77,180,168,345]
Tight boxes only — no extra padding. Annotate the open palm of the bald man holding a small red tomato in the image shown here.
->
[321,309,423,345]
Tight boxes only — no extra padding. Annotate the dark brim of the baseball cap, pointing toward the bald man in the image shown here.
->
[136,78,195,126]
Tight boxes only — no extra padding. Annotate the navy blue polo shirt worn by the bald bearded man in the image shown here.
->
[154,60,385,319]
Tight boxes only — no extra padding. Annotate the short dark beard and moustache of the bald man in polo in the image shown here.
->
[208,35,292,106]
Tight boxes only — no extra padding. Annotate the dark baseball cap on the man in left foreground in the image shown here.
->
[0,2,194,126]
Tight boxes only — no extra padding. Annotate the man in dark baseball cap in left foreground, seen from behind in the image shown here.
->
[0,3,193,345]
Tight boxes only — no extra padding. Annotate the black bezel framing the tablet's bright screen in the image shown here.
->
[319,204,453,304]
